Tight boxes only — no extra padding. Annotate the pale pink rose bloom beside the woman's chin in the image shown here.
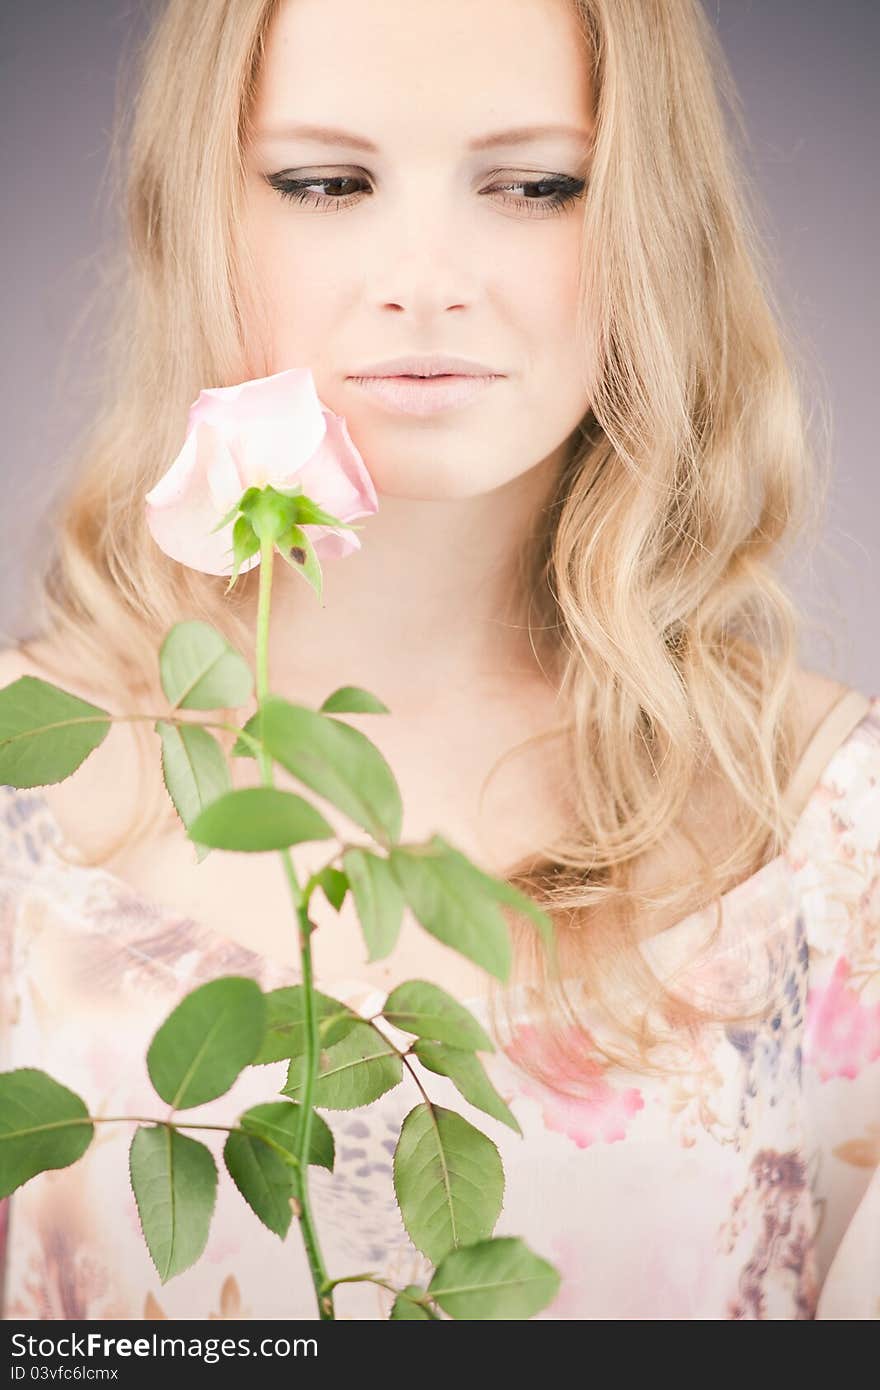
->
[145,367,378,574]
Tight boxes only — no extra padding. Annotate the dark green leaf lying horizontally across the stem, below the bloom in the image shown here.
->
[188,787,336,853]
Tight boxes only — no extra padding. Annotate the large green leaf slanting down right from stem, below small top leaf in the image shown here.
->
[260,695,403,841]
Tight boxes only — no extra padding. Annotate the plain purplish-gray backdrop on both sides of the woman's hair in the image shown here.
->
[0,0,880,694]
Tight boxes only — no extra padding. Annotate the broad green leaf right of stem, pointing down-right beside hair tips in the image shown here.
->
[388,844,512,980]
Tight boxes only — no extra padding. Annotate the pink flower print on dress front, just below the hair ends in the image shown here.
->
[505,1024,645,1148]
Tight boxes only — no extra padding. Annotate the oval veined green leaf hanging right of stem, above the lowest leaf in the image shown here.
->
[393,1104,505,1265]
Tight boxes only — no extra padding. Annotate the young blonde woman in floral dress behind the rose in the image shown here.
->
[0,0,880,1319]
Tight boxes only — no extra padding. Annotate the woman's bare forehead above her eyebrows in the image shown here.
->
[247,0,592,142]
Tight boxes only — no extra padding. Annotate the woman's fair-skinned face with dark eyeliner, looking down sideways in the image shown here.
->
[243,0,592,499]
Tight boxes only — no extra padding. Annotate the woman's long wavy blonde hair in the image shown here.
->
[19,0,827,1094]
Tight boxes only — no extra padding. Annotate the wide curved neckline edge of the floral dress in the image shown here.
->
[15,688,880,1012]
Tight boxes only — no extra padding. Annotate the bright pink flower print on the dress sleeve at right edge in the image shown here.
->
[804,956,880,1081]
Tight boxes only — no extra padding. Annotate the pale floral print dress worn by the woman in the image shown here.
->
[0,689,880,1321]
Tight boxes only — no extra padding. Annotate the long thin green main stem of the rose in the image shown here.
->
[256,539,335,1322]
